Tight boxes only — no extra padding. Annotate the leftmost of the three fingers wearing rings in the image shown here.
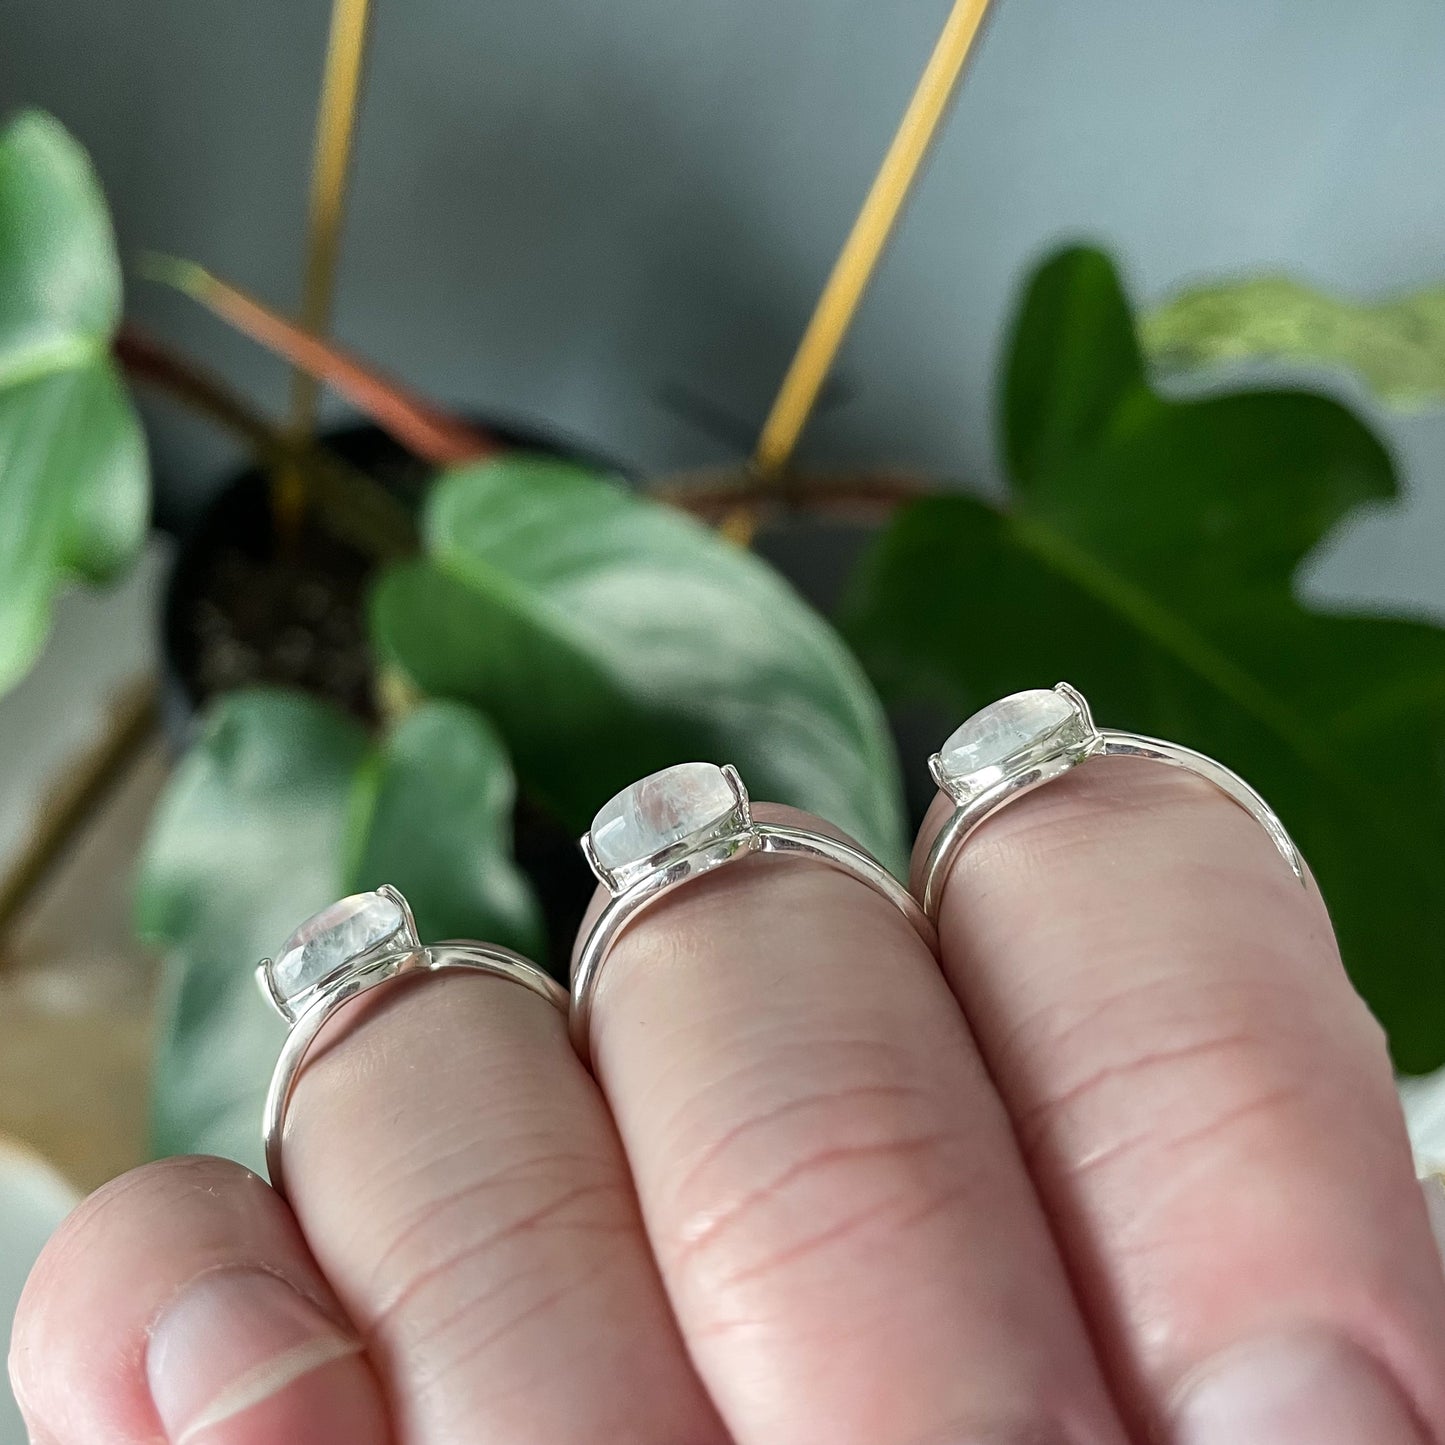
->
[285,971,721,1445]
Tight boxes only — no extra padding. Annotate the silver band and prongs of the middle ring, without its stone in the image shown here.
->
[569,763,938,1064]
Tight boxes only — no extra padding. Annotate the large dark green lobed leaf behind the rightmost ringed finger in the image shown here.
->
[847,250,1445,1071]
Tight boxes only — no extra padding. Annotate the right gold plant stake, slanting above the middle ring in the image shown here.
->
[751,0,988,485]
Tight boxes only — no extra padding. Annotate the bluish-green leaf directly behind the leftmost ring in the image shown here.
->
[137,689,539,1169]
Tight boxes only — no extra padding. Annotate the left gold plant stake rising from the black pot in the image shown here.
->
[273,0,370,539]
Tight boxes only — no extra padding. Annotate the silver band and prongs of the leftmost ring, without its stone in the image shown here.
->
[262,890,568,1198]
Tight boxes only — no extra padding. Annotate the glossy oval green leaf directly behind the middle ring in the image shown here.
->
[373,455,903,866]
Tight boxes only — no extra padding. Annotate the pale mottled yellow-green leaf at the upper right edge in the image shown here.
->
[1140,276,1445,410]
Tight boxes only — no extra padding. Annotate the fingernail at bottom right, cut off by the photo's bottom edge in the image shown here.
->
[1175,1334,1426,1445]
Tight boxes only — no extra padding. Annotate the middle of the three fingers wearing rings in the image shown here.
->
[575,809,1121,1445]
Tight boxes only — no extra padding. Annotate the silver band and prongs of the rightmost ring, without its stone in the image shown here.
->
[922,682,1305,923]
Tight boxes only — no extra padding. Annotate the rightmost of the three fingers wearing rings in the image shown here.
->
[918,760,1445,1445]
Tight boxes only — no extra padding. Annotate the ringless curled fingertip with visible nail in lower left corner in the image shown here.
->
[10,1159,392,1445]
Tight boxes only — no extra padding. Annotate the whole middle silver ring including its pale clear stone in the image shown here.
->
[569,763,938,1064]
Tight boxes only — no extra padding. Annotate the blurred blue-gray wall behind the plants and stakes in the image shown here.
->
[0,0,1445,613]
